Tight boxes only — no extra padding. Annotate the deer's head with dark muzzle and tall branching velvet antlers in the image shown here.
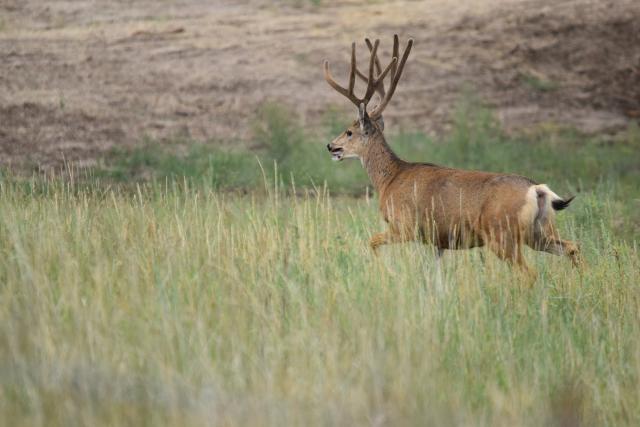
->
[324,34,413,160]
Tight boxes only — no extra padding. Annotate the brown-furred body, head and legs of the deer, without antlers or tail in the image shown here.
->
[330,121,580,279]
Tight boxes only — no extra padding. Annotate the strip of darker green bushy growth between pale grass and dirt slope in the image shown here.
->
[97,98,640,239]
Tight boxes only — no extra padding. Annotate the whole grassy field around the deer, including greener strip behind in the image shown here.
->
[0,103,640,426]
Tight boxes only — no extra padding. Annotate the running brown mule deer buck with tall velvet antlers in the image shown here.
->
[324,35,581,280]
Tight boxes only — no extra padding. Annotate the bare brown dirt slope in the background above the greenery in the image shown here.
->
[0,0,640,171]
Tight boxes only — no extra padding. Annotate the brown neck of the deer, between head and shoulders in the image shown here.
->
[362,133,402,193]
